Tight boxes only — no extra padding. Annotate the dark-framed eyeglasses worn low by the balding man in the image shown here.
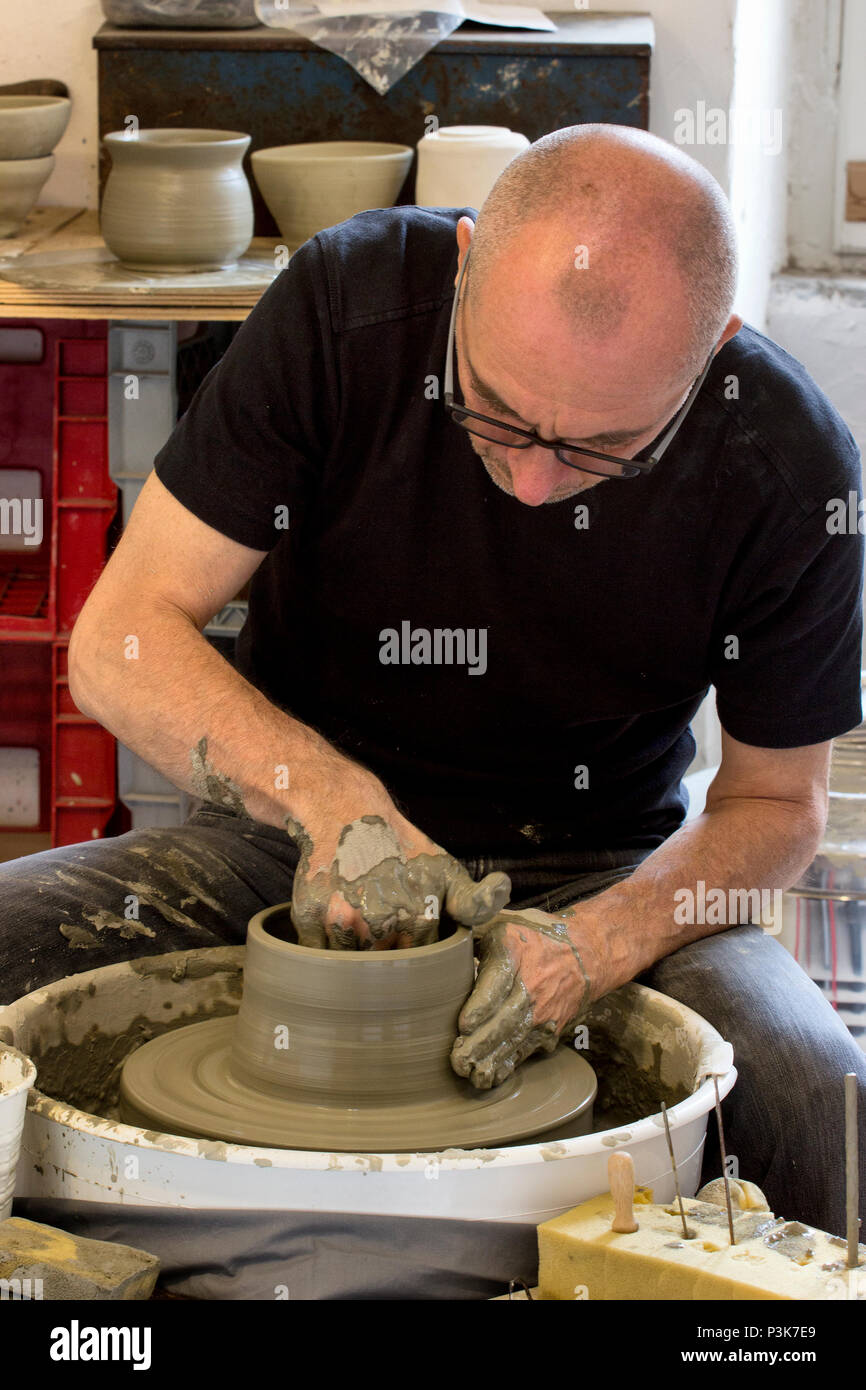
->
[442,240,714,478]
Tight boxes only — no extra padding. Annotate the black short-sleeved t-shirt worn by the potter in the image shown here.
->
[156,207,863,856]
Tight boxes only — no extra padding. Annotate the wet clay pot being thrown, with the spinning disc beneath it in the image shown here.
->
[120,904,596,1152]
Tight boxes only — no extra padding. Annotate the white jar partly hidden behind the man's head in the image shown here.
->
[416,125,530,209]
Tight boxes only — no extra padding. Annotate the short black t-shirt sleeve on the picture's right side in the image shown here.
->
[713,486,863,748]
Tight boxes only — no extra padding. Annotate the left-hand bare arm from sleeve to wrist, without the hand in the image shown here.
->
[70,474,364,827]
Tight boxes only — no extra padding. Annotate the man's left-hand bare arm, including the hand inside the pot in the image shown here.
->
[70,474,510,947]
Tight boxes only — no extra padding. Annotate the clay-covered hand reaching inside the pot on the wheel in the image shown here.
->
[292,816,512,951]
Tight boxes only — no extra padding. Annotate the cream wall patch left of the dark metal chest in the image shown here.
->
[0,0,104,207]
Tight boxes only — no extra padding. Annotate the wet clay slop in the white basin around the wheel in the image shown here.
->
[25,947,703,1150]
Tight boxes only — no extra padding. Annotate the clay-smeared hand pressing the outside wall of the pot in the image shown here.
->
[450,908,591,1090]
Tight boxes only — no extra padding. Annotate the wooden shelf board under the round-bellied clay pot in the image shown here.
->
[0,207,278,321]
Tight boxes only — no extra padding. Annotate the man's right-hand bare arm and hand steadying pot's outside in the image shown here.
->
[452,733,831,1087]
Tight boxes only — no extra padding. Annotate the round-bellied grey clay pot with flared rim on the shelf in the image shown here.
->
[100,129,253,272]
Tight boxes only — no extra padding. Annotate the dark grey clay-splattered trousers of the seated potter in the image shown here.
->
[0,805,866,1234]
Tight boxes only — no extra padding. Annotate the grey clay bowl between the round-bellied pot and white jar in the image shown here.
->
[252,140,413,250]
